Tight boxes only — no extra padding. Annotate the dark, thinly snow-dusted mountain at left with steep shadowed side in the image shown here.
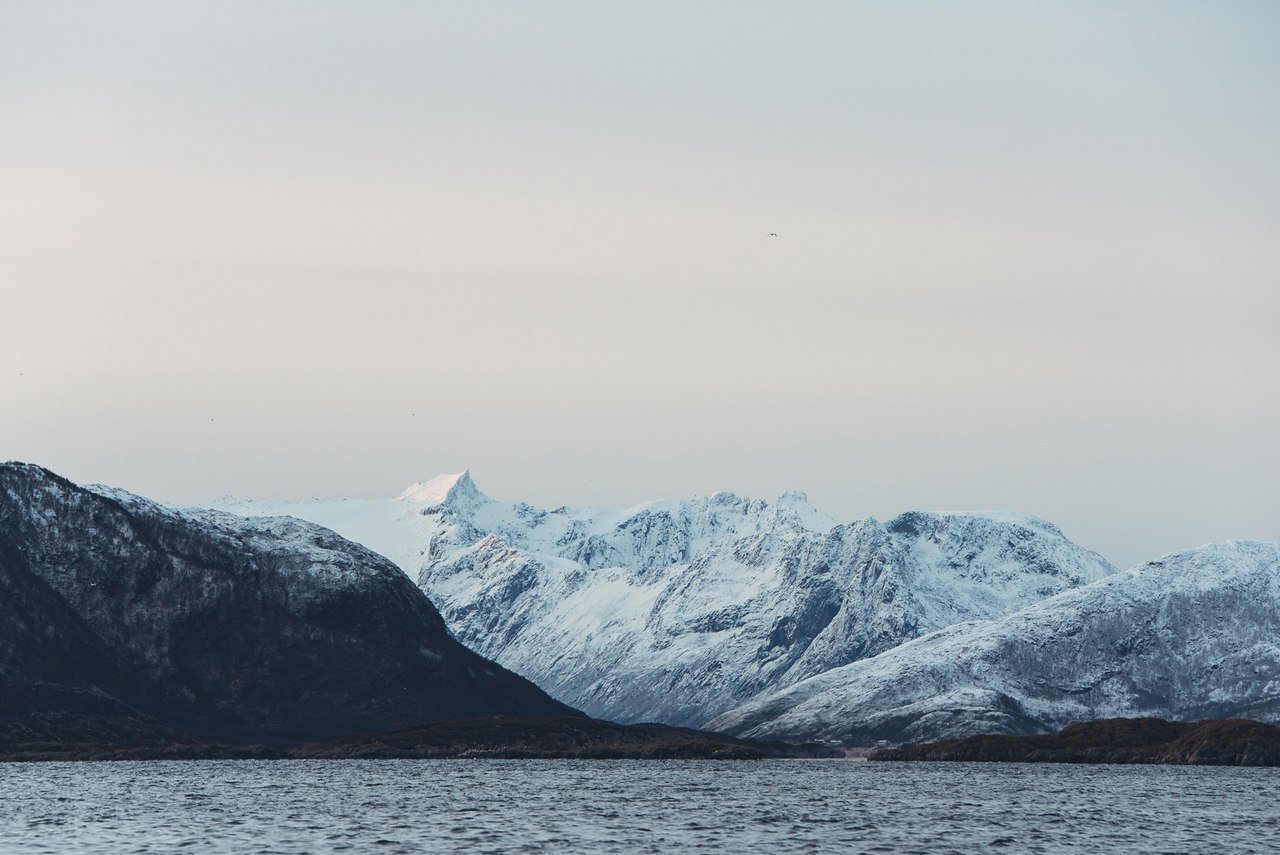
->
[0,463,576,741]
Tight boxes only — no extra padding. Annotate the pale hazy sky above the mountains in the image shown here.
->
[0,0,1280,566]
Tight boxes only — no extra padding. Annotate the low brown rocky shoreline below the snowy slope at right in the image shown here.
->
[870,718,1280,765]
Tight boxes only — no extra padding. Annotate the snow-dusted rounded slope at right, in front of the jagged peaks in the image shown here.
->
[708,541,1280,745]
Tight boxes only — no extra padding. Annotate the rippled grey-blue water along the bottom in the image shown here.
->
[0,760,1280,854]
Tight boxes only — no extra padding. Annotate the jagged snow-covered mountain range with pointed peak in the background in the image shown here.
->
[207,472,1114,726]
